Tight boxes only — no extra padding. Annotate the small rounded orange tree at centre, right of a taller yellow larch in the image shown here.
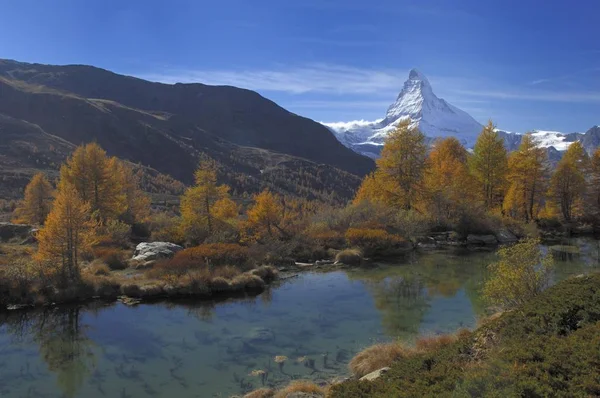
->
[246,190,284,239]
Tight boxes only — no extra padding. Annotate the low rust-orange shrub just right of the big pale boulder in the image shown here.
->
[180,243,249,266]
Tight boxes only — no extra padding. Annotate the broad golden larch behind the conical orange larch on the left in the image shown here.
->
[59,143,127,221]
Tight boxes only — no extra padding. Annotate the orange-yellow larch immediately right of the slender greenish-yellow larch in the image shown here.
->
[502,134,547,222]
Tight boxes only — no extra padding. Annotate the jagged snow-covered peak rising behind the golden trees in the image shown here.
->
[323,69,483,157]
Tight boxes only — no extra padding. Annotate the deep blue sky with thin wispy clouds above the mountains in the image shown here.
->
[0,0,600,132]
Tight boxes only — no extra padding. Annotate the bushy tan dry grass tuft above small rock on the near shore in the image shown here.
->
[348,343,409,378]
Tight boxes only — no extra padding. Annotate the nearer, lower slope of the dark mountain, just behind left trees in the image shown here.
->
[0,71,360,202]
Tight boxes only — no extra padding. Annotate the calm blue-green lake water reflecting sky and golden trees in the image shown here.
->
[0,240,598,398]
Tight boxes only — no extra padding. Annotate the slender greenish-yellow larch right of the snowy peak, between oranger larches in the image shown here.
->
[469,120,508,210]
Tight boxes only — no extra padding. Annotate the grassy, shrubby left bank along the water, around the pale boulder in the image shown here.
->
[0,244,278,309]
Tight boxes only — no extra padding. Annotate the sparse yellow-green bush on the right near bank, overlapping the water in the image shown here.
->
[483,239,553,309]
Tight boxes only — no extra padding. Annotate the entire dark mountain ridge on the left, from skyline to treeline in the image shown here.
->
[0,60,374,202]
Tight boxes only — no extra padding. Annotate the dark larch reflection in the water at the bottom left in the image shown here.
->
[1,307,96,397]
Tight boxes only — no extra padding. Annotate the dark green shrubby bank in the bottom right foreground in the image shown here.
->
[328,274,600,398]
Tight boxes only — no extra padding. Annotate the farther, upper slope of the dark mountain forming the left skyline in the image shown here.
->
[0,60,373,176]
